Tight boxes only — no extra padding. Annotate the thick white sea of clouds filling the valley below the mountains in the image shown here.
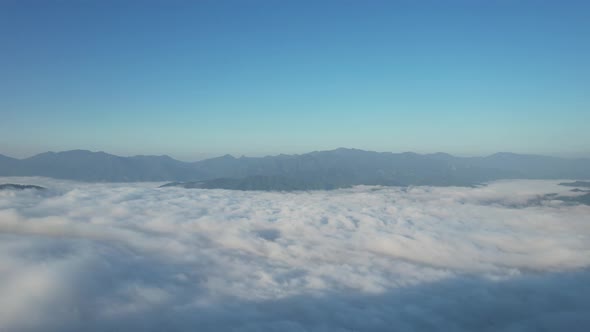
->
[0,178,590,331]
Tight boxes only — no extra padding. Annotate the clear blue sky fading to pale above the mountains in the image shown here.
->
[0,0,590,160]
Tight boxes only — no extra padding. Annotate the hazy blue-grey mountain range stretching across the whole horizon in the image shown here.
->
[0,148,590,190]
